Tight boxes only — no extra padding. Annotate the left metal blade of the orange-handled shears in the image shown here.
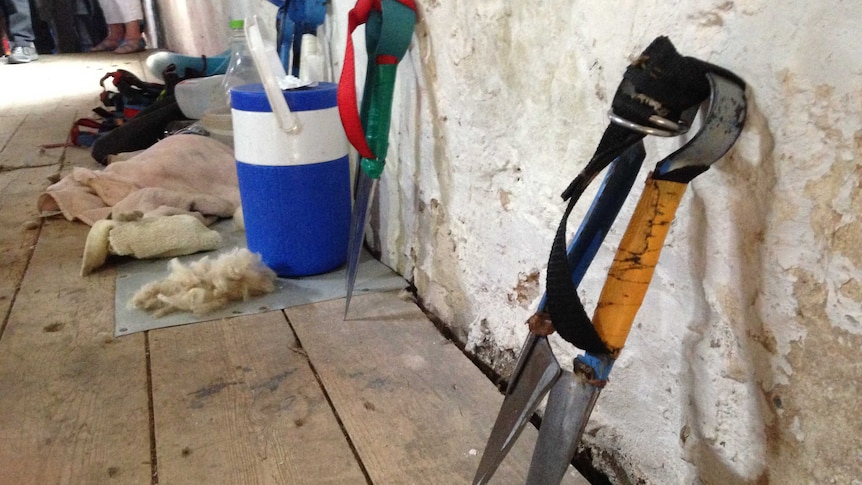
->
[473,334,561,485]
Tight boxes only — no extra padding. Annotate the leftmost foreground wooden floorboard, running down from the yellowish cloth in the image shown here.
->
[0,220,151,485]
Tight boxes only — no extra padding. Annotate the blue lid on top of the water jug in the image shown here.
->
[230,82,338,113]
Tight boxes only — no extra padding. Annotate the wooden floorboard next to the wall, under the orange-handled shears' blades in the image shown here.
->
[286,292,584,485]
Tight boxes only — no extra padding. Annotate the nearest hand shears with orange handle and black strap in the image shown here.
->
[473,37,746,484]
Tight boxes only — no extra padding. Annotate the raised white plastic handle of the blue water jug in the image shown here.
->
[245,15,298,133]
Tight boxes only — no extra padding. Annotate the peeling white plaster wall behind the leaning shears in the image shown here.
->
[327,0,862,485]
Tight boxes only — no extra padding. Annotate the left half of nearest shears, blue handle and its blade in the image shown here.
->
[473,143,646,484]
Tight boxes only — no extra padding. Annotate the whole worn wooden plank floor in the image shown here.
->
[0,54,586,485]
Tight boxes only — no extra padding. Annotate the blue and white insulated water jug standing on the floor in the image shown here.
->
[231,83,350,277]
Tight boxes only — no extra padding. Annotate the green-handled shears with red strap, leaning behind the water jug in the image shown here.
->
[338,0,416,318]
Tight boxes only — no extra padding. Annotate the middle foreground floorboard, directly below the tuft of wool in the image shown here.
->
[150,312,365,485]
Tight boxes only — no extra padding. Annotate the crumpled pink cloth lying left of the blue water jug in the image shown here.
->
[38,135,240,226]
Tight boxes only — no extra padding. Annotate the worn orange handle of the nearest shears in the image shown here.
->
[593,176,687,355]
